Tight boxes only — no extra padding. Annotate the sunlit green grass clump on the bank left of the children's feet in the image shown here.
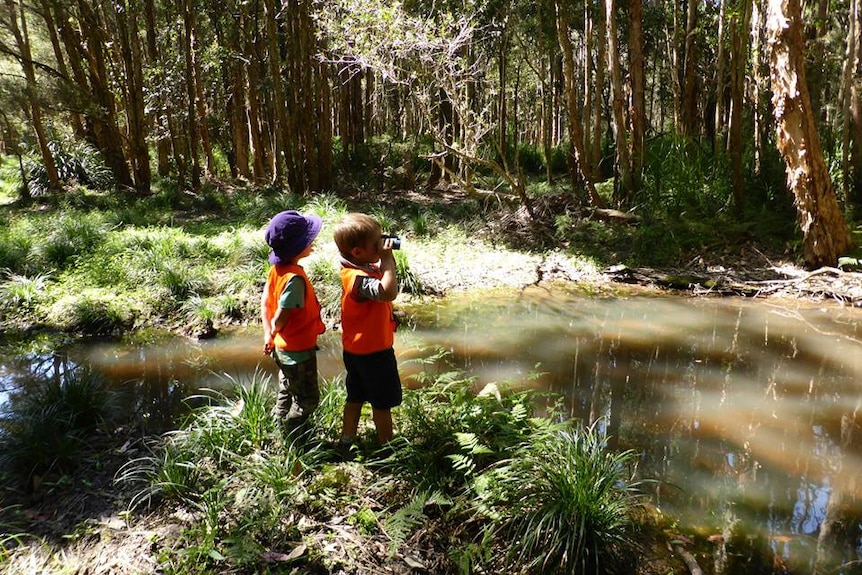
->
[117,372,319,573]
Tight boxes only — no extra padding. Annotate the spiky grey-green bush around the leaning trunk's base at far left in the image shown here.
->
[24,140,114,197]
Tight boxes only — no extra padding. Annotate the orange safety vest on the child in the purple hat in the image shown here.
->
[266,264,326,351]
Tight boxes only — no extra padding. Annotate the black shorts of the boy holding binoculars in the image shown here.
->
[343,347,401,409]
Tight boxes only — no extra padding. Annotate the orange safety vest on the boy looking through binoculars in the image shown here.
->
[341,267,395,355]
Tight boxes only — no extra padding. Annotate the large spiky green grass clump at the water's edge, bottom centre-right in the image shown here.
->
[475,419,645,574]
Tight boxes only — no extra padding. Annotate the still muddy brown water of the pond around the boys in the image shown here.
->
[0,288,862,564]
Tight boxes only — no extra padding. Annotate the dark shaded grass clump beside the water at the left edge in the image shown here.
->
[0,368,121,483]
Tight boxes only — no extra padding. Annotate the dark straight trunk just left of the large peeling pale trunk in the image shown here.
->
[729,0,752,215]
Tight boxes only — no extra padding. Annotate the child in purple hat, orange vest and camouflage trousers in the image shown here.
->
[260,210,325,435]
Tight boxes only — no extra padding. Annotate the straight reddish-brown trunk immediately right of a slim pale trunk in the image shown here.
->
[629,0,646,194]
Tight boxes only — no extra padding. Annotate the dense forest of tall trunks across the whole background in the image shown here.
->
[0,0,862,267]
